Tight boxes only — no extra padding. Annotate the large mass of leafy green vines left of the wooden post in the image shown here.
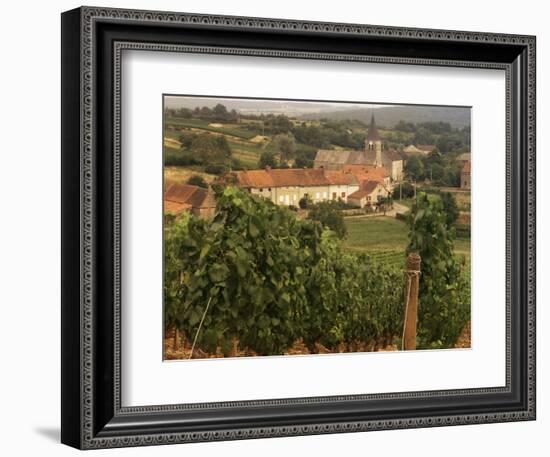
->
[164,187,410,355]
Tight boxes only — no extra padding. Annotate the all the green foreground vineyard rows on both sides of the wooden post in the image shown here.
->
[164,187,470,357]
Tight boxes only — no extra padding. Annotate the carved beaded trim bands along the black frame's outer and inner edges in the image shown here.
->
[62,7,536,449]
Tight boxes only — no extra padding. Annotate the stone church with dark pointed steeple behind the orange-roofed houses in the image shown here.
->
[314,114,403,181]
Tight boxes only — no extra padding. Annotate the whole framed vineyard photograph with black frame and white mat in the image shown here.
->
[62,7,536,449]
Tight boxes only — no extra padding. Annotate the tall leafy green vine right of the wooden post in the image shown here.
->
[407,192,470,348]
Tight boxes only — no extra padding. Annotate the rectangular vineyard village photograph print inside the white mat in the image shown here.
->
[162,94,472,360]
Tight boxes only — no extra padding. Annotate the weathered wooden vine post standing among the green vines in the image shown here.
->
[402,252,421,351]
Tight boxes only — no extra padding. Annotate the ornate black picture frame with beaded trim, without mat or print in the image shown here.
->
[61,7,536,449]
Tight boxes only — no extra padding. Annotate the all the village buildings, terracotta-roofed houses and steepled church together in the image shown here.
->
[164,116,471,217]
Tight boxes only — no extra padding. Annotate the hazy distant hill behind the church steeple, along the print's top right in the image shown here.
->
[301,105,470,128]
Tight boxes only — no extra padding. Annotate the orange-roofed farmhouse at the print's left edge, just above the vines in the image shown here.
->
[164,183,216,218]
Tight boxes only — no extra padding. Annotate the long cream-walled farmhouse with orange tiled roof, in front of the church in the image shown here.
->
[233,167,359,206]
